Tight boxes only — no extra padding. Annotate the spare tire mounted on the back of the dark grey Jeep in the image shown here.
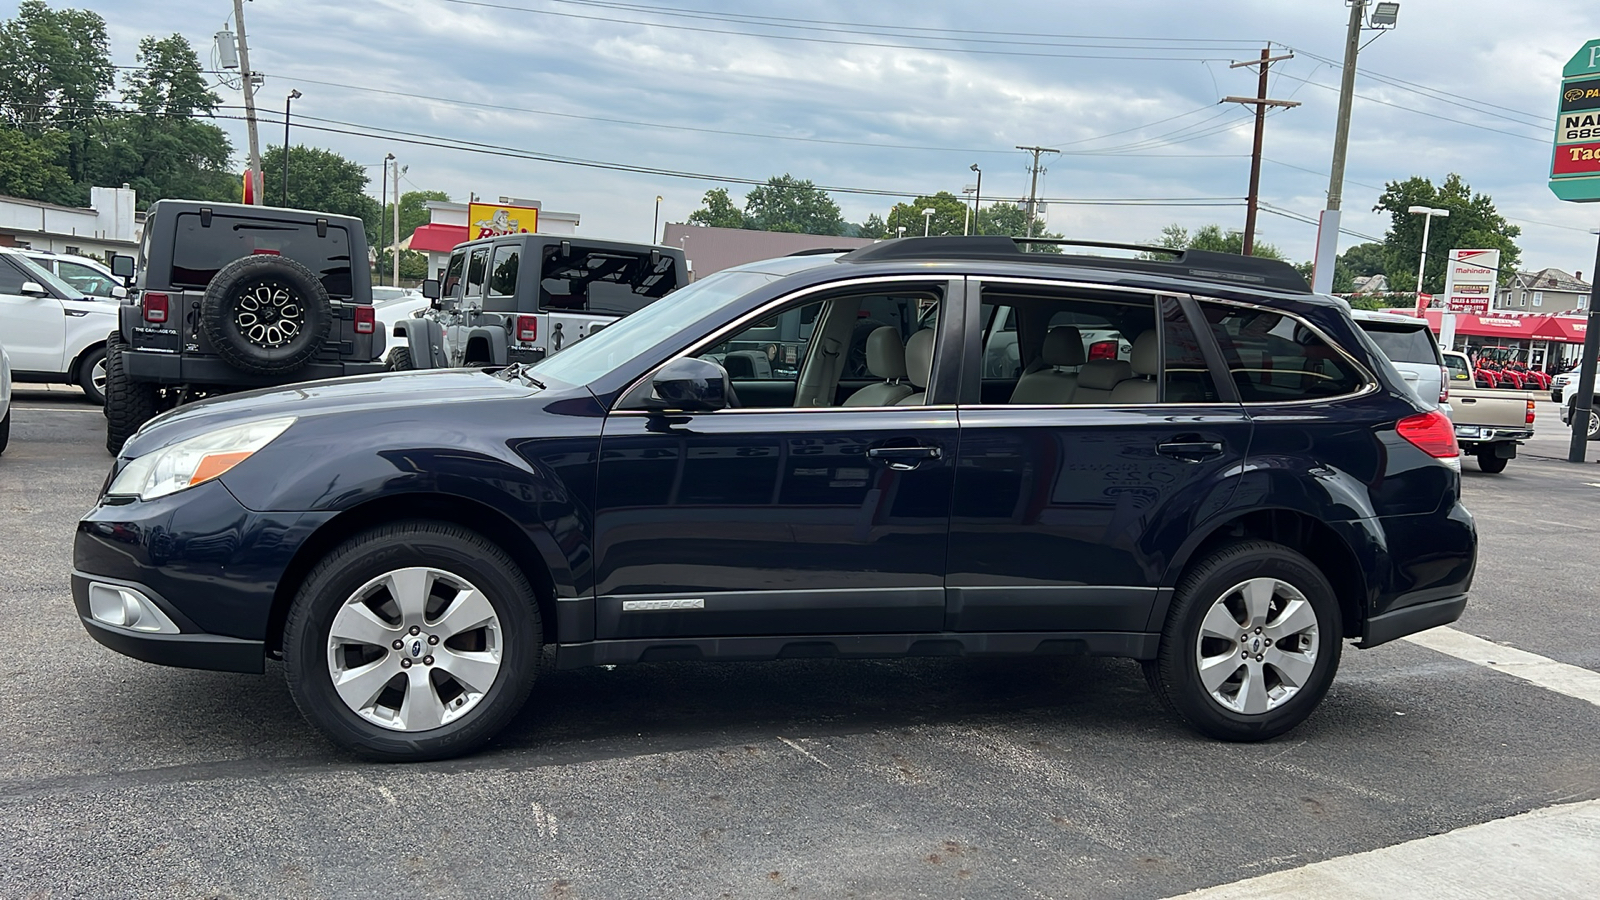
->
[200,255,333,375]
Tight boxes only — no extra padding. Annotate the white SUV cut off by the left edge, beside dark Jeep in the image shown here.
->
[0,250,117,404]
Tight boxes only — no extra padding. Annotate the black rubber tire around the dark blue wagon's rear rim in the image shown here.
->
[1144,541,1342,741]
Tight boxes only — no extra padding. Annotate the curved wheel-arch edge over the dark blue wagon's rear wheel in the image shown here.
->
[1146,506,1371,639]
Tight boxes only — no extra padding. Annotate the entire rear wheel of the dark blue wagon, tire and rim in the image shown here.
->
[1144,541,1342,741]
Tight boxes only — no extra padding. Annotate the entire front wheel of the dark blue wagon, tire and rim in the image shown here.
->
[283,520,542,762]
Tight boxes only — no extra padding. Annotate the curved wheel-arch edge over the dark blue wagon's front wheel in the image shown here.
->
[266,493,557,653]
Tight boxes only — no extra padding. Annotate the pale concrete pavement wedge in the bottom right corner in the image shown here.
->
[1164,801,1600,900]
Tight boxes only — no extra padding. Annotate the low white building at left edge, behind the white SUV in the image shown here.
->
[0,186,144,259]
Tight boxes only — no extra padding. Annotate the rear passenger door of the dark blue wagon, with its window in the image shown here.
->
[947,279,1251,633]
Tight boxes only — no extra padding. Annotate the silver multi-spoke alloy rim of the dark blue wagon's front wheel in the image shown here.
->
[328,567,502,732]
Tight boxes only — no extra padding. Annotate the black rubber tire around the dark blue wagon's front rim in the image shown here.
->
[283,520,544,762]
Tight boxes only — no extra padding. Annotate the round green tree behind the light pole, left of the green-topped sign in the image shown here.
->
[1373,173,1522,293]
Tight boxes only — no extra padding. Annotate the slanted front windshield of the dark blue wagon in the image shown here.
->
[533,269,778,384]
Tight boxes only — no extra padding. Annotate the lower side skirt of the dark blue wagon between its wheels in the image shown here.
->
[555,631,1162,669]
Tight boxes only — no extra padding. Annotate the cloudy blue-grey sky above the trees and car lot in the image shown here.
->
[12,0,1600,274]
